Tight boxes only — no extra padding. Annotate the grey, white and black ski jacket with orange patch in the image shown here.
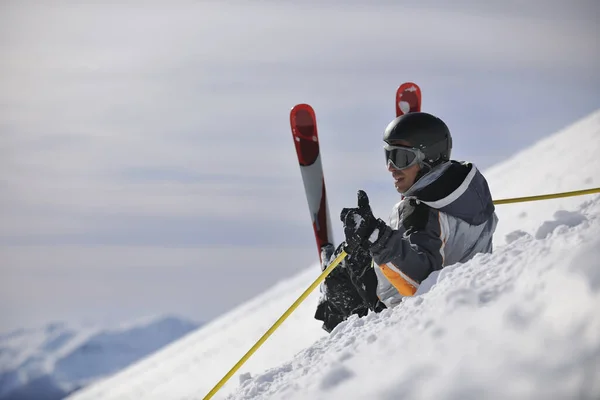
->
[370,161,498,307]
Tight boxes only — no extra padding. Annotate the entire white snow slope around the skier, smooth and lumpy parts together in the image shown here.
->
[70,110,600,400]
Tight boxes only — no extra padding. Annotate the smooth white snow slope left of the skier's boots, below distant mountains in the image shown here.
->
[67,266,326,400]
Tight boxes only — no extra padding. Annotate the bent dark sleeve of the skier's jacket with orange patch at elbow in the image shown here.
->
[370,201,445,296]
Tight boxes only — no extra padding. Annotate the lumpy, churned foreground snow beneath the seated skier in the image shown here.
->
[230,196,600,400]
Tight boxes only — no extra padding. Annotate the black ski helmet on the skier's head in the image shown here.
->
[383,112,452,167]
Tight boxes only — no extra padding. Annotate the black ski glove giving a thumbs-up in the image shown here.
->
[340,190,391,253]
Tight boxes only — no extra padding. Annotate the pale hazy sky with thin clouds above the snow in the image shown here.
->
[0,0,600,331]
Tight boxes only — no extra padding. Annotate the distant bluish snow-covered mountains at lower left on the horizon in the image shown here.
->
[0,316,199,400]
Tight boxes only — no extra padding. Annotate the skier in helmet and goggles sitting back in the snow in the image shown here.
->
[315,112,498,332]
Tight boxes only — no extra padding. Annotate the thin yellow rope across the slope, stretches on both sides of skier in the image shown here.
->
[203,188,600,400]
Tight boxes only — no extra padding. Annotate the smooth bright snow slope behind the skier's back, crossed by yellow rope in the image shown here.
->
[484,109,600,247]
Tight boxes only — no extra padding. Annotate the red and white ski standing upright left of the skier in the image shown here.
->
[290,104,333,260]
